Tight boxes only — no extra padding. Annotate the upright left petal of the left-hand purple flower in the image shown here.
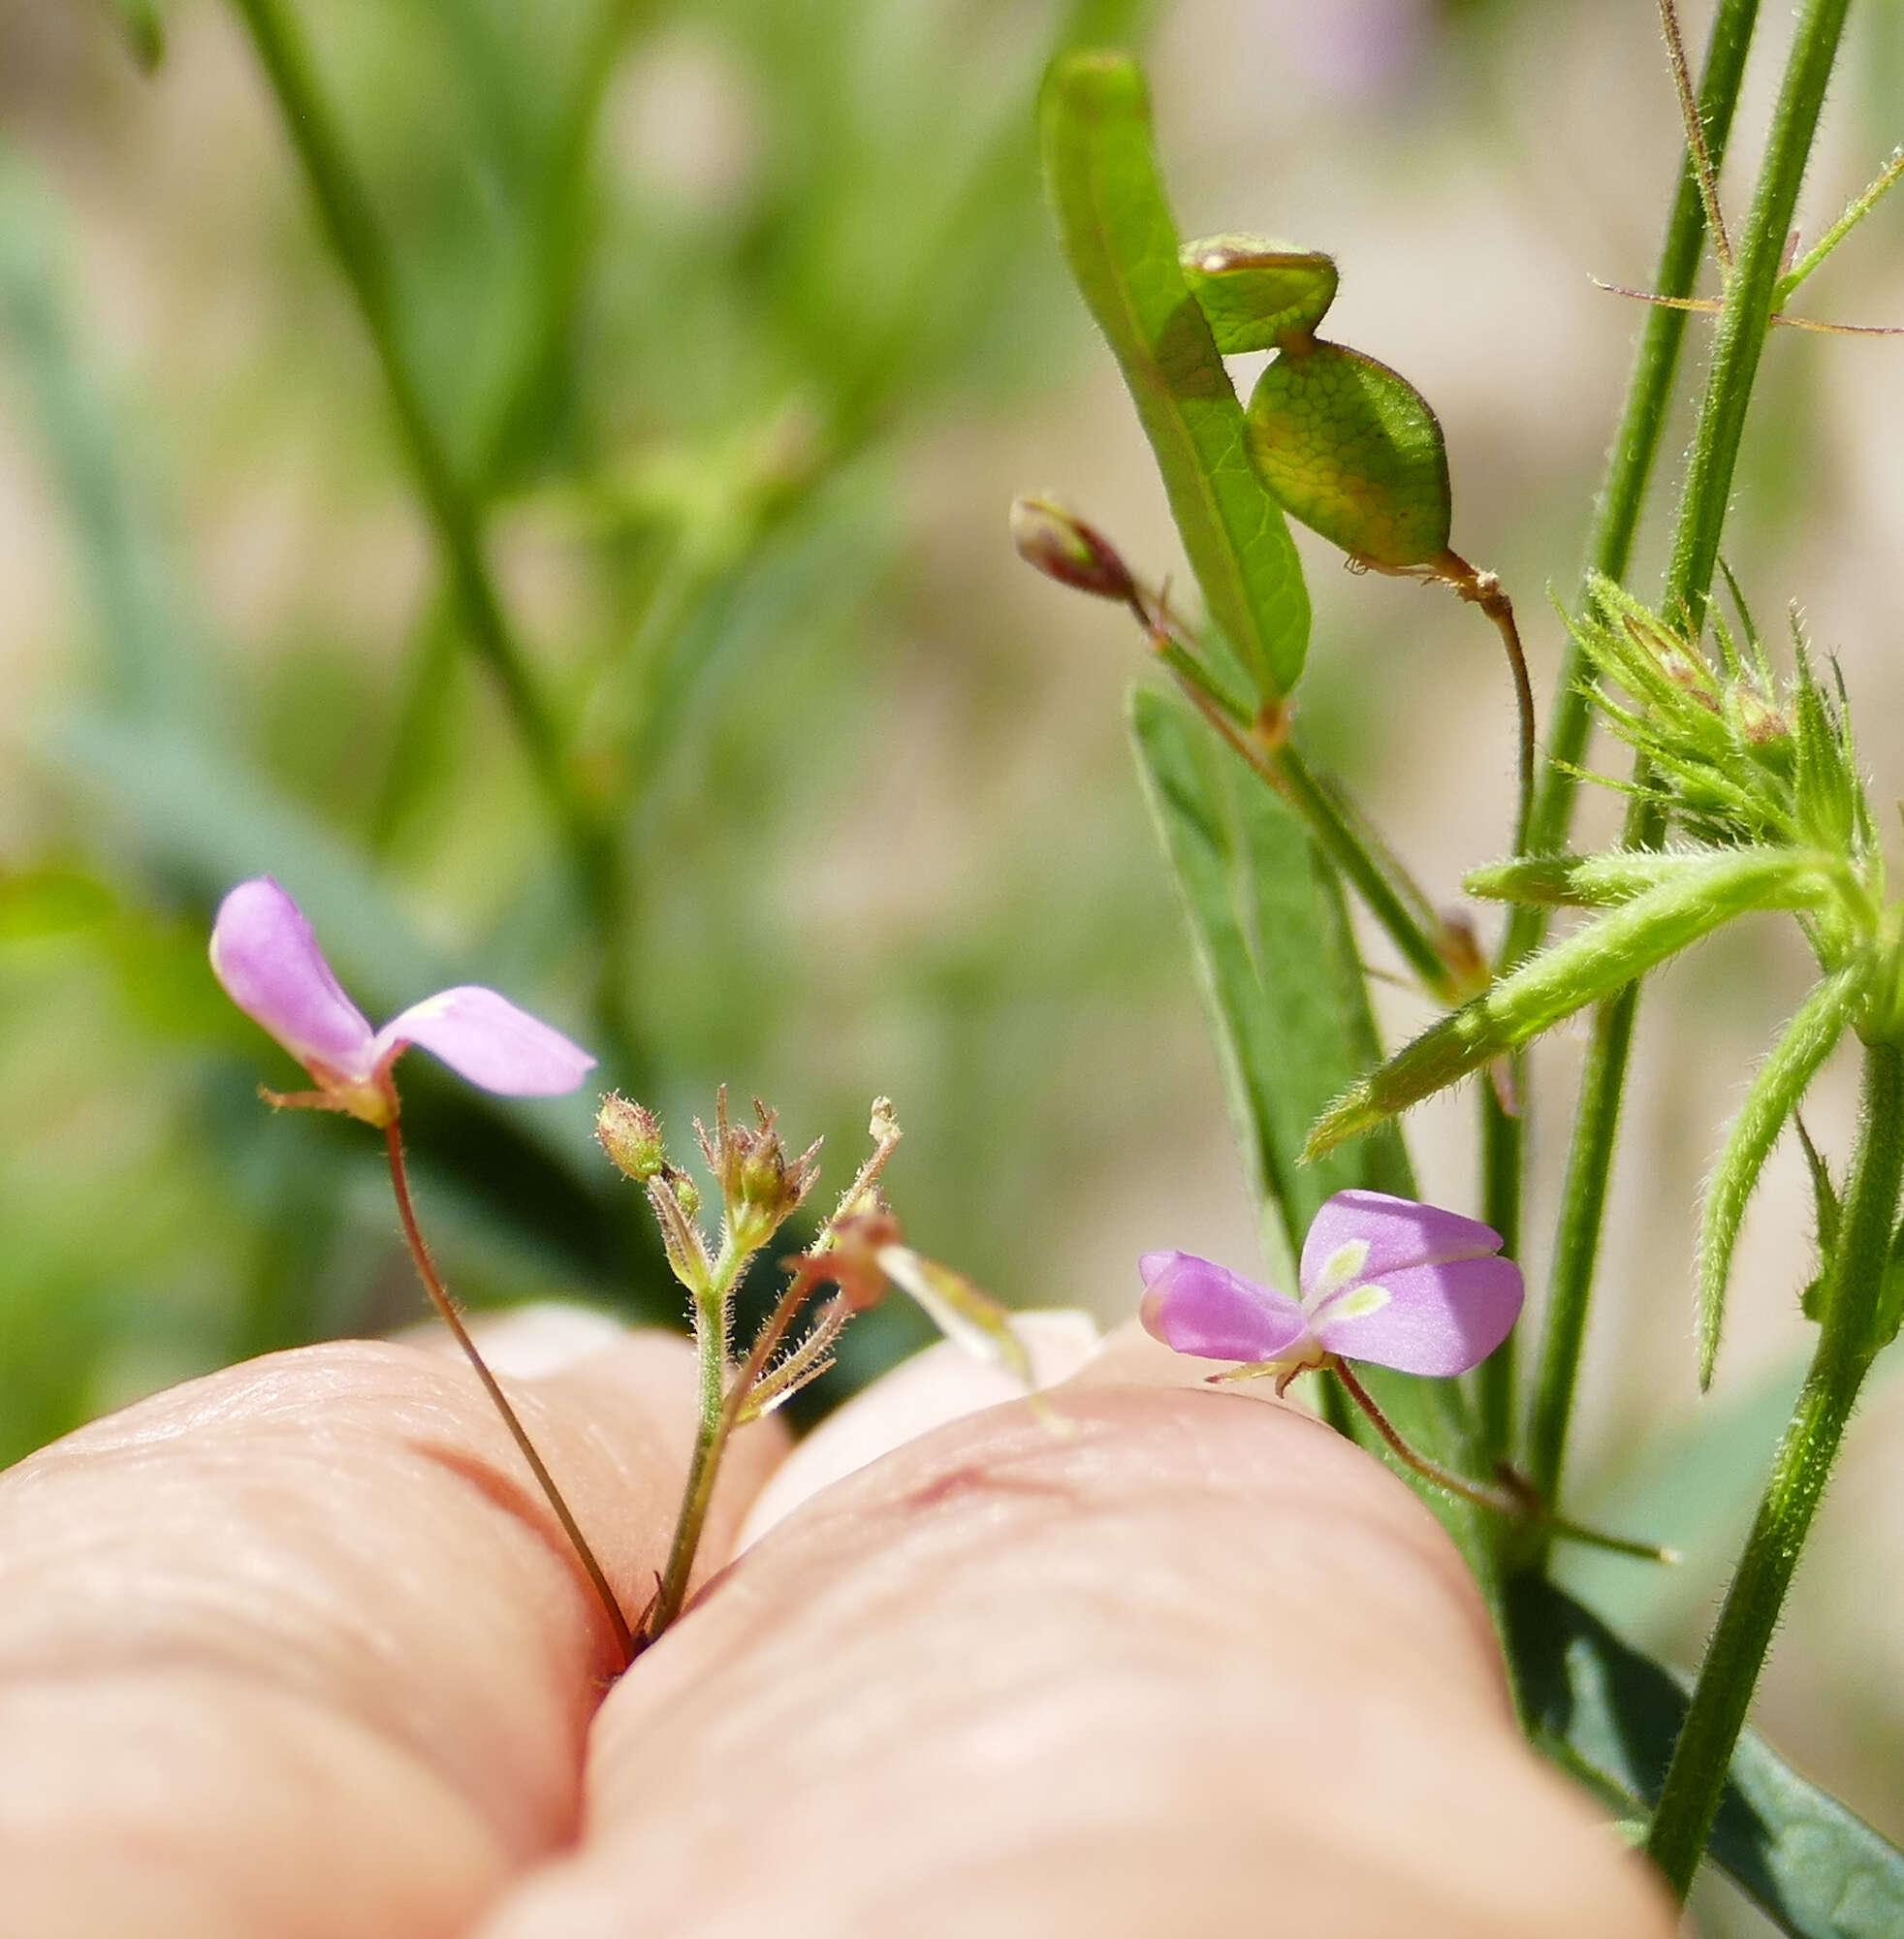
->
[211,874,376,1082]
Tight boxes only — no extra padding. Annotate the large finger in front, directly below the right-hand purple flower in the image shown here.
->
[483,1350,1671,1939]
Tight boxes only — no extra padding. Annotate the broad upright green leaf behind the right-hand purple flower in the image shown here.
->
[1130,688,1499,1596]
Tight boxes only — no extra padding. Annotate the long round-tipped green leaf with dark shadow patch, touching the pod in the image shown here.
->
[1041,52,1309,700]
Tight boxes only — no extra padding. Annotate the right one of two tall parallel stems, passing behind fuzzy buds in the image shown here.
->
[1532,0,1848,1497]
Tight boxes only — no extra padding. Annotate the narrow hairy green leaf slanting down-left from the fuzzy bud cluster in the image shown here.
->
[1307,849,1834,1158]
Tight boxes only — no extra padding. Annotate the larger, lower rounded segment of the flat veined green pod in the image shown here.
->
[1247,341,1450,572]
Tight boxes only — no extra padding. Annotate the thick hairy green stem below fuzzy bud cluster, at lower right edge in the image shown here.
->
[1646,1043,1904,1898]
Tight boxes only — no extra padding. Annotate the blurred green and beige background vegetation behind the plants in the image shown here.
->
[0,0,1904,1933]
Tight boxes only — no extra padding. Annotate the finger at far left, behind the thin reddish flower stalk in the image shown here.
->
[0,1334,777,1939]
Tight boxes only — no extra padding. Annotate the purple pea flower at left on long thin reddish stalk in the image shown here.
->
[211,874,595,1127]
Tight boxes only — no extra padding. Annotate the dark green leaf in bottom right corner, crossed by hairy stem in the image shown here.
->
[1508,1576,1904,1939]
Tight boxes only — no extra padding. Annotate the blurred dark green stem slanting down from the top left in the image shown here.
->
[237,0,638,1084]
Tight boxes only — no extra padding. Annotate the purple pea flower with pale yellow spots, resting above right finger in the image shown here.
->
[1138,1191,1524,1392]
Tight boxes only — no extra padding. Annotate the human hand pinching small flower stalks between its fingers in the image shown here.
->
[0,1319,1673,1939]
